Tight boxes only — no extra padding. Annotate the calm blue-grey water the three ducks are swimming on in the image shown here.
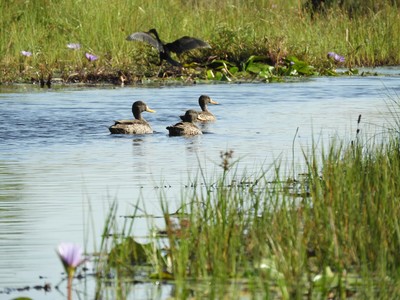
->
[0,69,400,299]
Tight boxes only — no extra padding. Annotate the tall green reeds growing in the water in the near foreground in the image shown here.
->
[99,102,400,299]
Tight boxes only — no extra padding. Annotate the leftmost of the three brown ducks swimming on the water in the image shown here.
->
[108,101,155,134]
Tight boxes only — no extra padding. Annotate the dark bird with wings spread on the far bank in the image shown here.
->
[126,29,211,67]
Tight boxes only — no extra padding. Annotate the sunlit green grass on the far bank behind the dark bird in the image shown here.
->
[0,0,400,83]
